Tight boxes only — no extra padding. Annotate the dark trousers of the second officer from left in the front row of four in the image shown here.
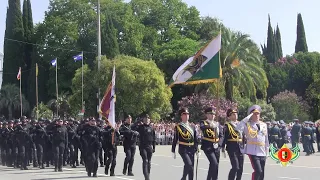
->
[203,148,220,180]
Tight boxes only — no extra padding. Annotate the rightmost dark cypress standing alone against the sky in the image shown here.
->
[295,13,308,53]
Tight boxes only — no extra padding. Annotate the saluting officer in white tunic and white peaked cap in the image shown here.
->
[237,105,269,180]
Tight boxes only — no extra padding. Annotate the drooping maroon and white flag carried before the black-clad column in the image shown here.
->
[99,66,116,128]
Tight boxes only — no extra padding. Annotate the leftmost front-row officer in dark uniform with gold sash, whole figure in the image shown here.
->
[171,108,199,180]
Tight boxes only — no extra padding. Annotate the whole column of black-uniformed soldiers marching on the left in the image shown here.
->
[0,114,156,180]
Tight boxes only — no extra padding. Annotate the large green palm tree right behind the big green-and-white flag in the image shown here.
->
[221,28,268,101]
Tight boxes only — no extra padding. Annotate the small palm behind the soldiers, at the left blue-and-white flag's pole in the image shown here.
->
[47,92,70,117]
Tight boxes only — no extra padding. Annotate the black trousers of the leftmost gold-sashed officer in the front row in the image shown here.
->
[179,149,194,180]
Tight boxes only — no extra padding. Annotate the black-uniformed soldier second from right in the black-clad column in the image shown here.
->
[119,115,139,176]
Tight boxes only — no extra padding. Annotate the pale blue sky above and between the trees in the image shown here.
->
[0,0,320,55]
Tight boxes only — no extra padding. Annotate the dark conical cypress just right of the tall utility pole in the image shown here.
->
[102,13,120,59]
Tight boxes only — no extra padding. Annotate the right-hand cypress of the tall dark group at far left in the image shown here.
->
[22,0,34,102]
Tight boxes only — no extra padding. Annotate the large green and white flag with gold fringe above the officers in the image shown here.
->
[169,33,222,87]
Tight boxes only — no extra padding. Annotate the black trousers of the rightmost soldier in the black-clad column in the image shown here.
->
[139,145,153,180]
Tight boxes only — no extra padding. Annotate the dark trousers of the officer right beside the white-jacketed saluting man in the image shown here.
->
[228,151,244,180]
